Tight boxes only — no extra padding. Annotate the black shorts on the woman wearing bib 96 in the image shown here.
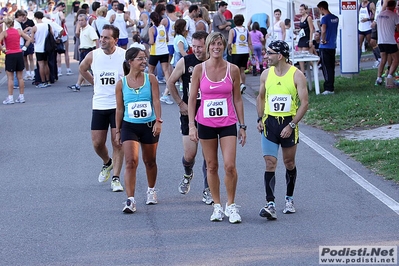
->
[121,120,159,144]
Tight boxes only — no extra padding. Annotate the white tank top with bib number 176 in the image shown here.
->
[91,47,126,110]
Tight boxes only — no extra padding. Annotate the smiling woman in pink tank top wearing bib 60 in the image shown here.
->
[188,32,246,223]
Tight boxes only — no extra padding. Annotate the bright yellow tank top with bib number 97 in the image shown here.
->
[264,66,298,117]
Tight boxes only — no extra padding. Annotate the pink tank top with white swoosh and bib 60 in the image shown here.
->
[195,62,237,127]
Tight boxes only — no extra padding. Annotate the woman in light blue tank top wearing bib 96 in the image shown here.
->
[115,47,163,213]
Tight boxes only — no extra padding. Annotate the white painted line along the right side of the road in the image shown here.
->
[243,94,399,215]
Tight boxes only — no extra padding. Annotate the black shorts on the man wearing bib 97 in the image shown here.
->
[264,115,299,148]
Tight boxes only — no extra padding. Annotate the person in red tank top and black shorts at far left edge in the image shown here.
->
[0,17,31,104]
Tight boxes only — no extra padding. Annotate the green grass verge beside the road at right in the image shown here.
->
[303,70,399,182]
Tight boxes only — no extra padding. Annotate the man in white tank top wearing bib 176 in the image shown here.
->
[79,24,125,192]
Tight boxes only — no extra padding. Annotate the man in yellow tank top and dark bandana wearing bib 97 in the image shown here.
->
[256,41,308,220]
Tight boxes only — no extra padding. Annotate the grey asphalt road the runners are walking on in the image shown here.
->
[0,15,399,265]
